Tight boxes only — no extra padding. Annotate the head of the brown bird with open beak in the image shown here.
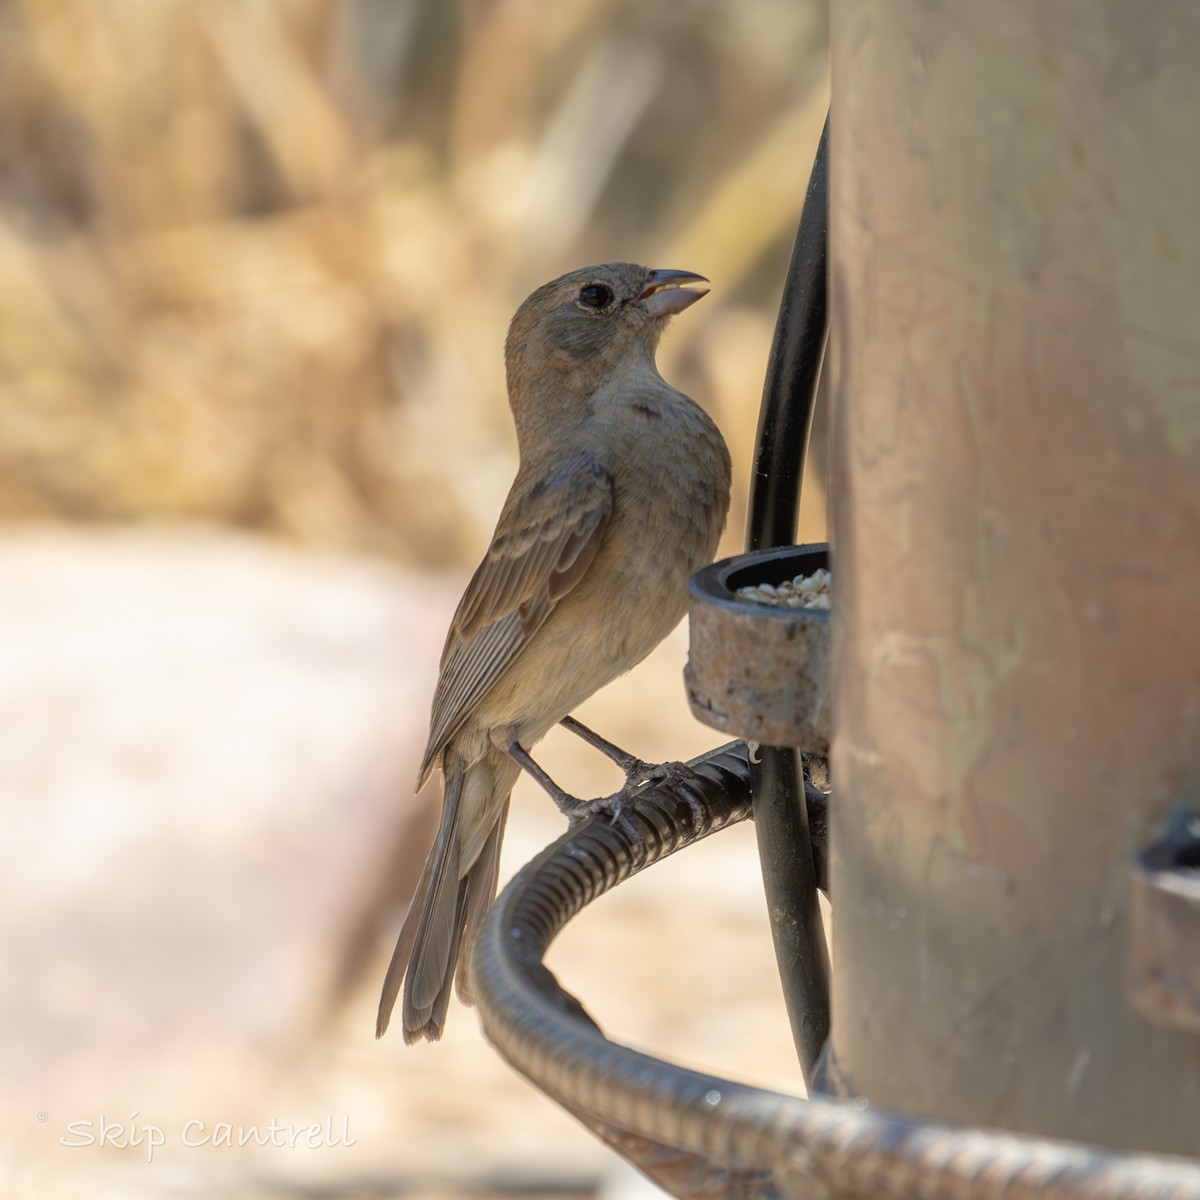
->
[505,263,708,402]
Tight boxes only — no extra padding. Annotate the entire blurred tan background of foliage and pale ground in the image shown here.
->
[0,0,828,1196]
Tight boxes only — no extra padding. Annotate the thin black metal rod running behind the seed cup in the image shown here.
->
[746,118,829,1091]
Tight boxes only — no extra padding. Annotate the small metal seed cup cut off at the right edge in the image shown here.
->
[1129,808,1200,1033]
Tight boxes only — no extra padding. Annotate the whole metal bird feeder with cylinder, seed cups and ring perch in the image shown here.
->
[473,0,1200,1200]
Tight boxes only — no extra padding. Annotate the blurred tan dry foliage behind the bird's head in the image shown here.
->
[0,0,826,563]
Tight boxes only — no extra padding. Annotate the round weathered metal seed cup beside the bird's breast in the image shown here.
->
[684,544,830,755]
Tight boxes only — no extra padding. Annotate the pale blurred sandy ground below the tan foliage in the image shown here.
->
[0,534,802,1198]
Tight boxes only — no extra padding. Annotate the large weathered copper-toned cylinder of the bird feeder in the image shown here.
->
[829,0,1200,1154]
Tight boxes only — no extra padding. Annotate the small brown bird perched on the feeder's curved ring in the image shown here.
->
[376,263,730,1043]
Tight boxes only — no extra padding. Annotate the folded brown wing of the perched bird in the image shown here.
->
[420,454,612,780]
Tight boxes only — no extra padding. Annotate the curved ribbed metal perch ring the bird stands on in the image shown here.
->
[472,745,1200,1200]
